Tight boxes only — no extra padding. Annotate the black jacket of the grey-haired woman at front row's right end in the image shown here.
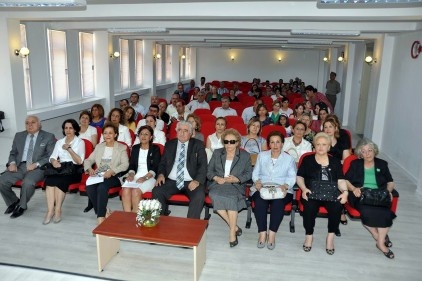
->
[346,157,393,188]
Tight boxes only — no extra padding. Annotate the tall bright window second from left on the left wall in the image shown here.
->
[48,29,69,104]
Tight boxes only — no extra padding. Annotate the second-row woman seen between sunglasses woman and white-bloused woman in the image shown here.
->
[240,117,267,154]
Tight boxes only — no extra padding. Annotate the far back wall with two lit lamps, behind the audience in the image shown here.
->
[196,48,325,87]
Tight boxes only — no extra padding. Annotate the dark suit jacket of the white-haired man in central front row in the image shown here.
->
[158,138,207,184]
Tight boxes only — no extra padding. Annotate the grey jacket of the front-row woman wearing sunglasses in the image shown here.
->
[207,148,252,193]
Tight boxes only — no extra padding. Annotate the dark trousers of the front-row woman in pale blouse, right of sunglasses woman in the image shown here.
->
[252,191,293,232]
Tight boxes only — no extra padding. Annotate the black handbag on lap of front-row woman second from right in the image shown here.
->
[308,167,340,202]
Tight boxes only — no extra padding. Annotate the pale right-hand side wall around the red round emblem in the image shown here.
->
[381,32,422,190]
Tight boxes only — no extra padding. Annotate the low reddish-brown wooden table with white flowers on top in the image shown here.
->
[92,211,208,280]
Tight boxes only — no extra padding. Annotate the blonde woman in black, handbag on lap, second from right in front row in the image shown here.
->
[296,132,348,255]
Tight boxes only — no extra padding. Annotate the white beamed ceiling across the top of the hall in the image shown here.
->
[0,0,422,49]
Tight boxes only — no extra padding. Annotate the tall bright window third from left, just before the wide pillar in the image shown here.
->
[79,32,95,98]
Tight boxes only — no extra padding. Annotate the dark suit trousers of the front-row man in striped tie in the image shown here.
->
[152,179,205,219]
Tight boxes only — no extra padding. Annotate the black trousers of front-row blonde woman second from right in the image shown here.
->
[301,198,343,235]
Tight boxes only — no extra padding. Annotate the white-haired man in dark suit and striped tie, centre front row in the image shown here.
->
[152,121,207,219]
